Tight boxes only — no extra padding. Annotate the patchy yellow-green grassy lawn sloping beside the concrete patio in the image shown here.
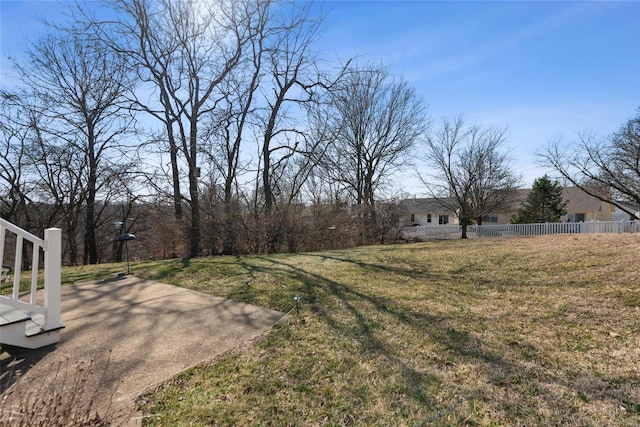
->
[69,234,640,426]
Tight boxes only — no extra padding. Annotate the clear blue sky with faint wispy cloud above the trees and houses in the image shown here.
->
[0,0,640,194]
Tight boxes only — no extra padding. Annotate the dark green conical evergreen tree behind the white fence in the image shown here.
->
[512,175,567,224]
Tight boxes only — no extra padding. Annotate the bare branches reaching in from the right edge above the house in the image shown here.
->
[538,109,640,219]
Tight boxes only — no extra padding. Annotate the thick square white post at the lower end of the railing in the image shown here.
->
[43,228,62,329]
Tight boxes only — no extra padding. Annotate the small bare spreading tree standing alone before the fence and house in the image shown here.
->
[419,118,520,239]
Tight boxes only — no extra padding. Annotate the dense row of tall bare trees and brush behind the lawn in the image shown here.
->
[0,0,638,264]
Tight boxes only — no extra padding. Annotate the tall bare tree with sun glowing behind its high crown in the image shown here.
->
[93,0,268,257]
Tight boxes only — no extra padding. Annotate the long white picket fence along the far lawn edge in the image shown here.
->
[401,221,640,240]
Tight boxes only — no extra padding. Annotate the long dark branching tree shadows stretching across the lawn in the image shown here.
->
[236,254,640,421]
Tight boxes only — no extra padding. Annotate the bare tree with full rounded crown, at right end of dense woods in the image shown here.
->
[314,65,428,240]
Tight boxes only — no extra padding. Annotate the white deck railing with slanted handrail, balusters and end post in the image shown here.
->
[0,218,62,330]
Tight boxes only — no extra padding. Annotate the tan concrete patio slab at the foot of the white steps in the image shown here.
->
[0,276,284,422]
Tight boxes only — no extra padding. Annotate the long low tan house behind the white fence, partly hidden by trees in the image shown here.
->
[401,187,615,227]
